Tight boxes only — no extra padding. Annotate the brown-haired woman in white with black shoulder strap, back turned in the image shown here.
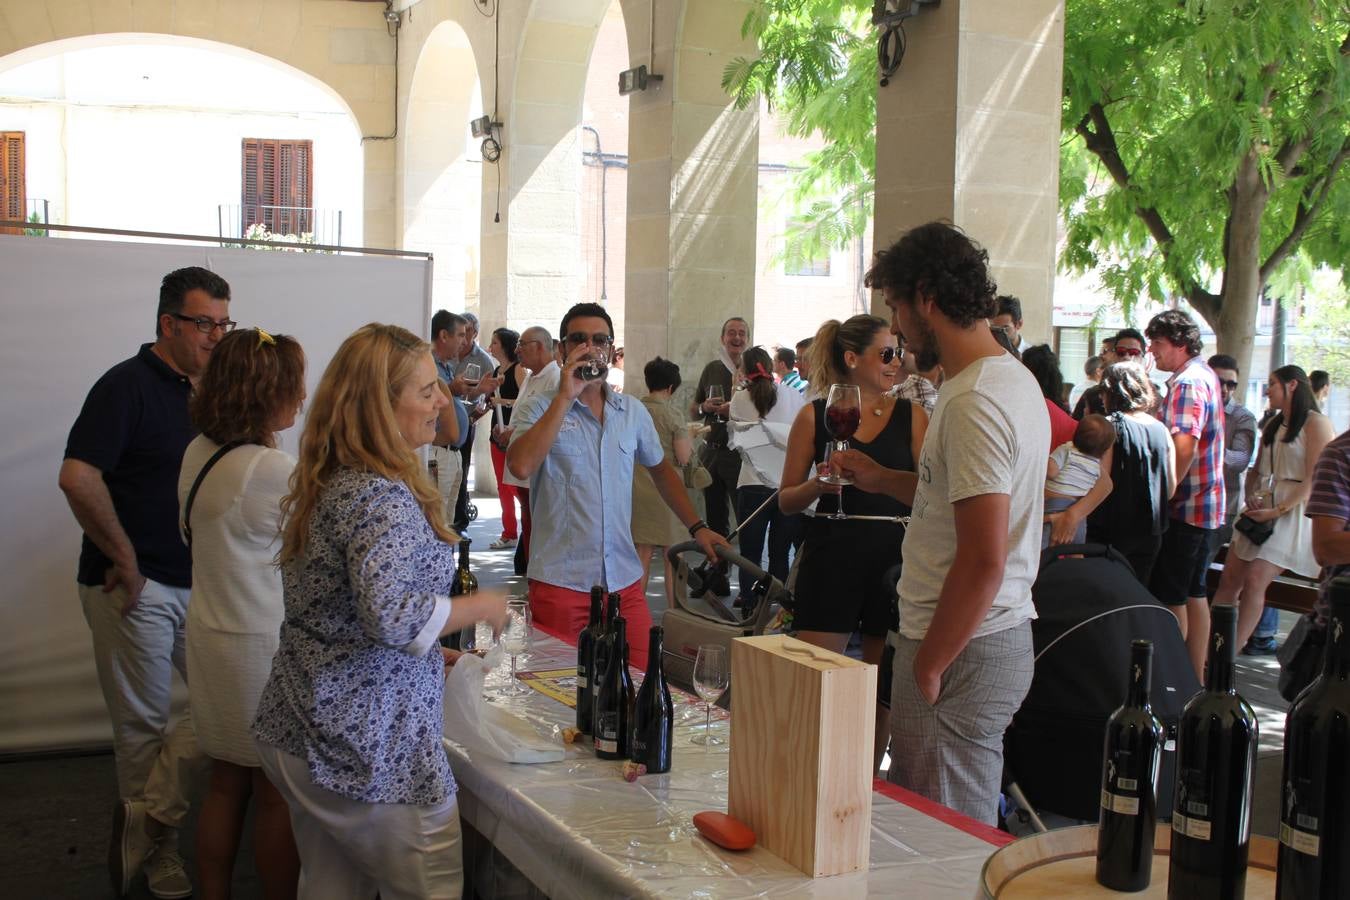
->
[178,329,305,900]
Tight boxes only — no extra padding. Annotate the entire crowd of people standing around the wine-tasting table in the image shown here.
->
[61,223,1350,900]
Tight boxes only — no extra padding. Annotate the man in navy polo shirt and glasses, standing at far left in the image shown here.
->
[61,267,235,897]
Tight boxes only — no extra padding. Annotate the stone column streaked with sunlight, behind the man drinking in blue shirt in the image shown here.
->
[624,0,759,405]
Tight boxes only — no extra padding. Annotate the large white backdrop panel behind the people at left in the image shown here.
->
[0,236,431,753]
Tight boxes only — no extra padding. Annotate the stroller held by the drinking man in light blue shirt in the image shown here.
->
[662,541,790,708]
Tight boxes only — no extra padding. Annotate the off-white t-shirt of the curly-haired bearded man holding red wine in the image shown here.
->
[899,354,1050,640]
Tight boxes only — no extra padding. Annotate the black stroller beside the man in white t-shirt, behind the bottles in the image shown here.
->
[1003,544,1200,823]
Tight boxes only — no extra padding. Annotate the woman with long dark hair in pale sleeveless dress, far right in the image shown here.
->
[1214,366,1335,646]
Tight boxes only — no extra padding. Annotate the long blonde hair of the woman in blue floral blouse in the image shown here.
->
[277,322,459,563]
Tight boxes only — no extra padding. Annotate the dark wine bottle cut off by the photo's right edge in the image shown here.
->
[1274,576,1350,900]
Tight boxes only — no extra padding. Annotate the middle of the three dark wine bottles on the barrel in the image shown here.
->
[1168,603,1257,900]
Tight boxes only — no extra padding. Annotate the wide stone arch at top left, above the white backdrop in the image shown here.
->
[0,0,397,247]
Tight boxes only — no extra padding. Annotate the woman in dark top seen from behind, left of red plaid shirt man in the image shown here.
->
[1087,363,1176,586]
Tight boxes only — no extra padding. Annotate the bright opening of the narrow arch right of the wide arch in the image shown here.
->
[397,19,483,310]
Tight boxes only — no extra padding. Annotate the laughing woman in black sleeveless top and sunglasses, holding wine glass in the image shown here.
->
[779,316,927,764]
